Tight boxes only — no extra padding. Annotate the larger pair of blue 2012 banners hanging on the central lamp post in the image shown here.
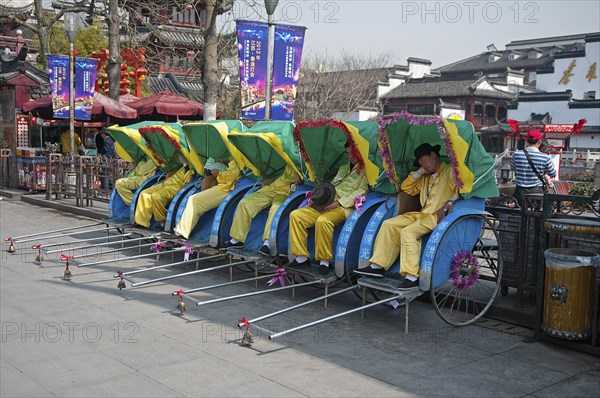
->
[236,20,306,120]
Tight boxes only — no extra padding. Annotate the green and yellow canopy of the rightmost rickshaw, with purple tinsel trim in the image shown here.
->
[378,113,499,198]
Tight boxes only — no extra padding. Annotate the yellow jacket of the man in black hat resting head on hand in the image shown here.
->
[400,163,457,214]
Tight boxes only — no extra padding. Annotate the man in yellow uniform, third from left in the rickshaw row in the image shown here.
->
[175,159,240,239]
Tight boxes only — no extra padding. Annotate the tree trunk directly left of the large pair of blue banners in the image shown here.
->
[202,0,221,120]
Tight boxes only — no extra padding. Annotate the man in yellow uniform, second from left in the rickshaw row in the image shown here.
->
[135,165,194,228]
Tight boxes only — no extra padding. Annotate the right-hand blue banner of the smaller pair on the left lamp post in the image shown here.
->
[75,57,98,120]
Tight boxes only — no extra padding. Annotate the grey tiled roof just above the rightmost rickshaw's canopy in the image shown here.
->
[382,76,514,99]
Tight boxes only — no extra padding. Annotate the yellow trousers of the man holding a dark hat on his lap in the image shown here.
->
[290,207,352,261]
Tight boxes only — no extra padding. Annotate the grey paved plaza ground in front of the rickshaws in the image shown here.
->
[0,198,600,398]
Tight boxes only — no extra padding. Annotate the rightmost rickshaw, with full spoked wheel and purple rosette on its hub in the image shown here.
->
[237,113,502,339]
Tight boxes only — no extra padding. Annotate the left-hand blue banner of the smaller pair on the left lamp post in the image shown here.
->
[48,54,70,119]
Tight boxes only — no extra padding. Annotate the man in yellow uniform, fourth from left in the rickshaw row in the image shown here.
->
[222,165,301,256]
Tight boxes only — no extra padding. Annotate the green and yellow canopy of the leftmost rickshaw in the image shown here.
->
[106,122,160,165]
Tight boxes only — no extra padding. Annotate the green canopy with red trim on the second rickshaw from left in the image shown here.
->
[138,122,203,173]
